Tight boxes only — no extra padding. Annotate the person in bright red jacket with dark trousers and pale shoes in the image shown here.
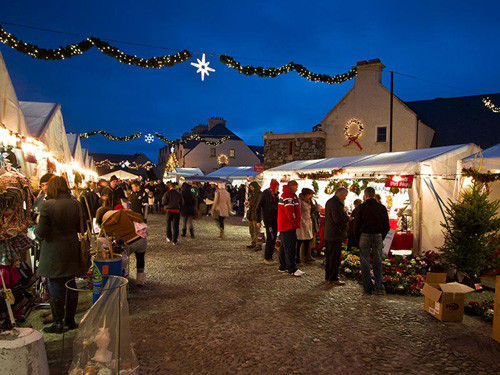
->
[278,181,304,277]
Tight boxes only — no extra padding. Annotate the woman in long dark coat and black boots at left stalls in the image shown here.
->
[35,176,84,333]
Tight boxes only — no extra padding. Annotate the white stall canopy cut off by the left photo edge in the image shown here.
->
[0,53,30,136]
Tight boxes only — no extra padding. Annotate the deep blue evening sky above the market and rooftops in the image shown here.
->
[0,0,500,161]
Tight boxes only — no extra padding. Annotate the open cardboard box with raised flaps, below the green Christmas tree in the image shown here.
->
[422,272,474,322]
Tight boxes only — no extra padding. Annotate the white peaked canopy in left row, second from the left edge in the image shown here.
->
[20,102,73,163]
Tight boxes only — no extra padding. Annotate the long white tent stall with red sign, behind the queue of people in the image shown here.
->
[264,144,477,252]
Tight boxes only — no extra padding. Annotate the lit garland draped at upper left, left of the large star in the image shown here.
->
[0,25,191,69]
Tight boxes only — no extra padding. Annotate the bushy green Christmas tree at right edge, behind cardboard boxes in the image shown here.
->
[439,182,500,281]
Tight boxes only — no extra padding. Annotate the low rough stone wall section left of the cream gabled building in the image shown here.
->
[264,132,326,169]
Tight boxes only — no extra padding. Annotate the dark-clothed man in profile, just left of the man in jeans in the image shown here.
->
[324,188,349,285]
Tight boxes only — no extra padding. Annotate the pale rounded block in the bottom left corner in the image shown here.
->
[0,328,49,375]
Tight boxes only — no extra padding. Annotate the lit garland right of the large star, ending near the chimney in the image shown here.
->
[219,55,357,84]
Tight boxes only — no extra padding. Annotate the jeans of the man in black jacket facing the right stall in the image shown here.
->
[359,233,384,293]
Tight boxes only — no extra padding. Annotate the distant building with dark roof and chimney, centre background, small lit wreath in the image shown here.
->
[158,117,262,174]
